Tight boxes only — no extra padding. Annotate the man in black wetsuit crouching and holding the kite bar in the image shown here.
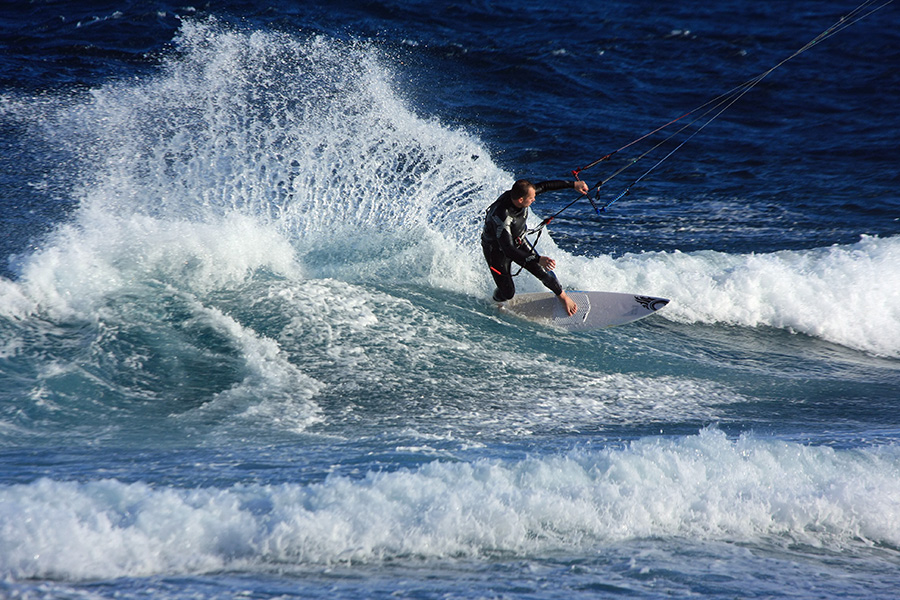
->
[481,179,588,315]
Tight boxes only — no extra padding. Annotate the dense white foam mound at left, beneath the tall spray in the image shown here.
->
[0,211,301,319]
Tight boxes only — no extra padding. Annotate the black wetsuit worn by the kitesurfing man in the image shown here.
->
[481,181,575,302]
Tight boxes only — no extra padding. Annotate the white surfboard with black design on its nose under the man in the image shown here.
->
[500,291,669,331]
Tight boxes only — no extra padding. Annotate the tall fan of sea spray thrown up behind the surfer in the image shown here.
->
[4,21,508,314]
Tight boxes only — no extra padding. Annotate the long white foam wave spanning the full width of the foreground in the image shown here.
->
[0,430,900,579]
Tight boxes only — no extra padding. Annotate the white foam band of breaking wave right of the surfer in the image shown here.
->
[560,236,900,357]
